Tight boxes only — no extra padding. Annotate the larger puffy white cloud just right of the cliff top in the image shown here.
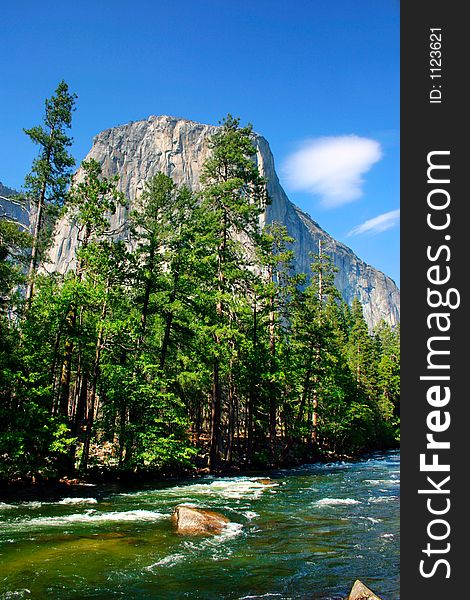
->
[283,135,382,208]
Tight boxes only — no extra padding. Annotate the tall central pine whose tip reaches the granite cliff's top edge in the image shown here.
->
[201,115,267,469]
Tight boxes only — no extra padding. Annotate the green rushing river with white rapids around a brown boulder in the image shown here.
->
[0,452,400,600]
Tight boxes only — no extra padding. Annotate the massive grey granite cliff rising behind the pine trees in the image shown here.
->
[47,116,400,327]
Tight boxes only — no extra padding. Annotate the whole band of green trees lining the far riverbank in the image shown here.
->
[0,82,399,481]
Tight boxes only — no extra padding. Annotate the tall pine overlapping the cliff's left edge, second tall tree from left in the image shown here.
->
[58,159,125,468]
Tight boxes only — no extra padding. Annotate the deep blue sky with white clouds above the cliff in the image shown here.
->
[0,0,399,283]
